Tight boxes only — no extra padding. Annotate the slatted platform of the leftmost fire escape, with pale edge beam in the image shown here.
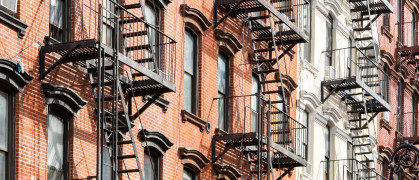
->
[40,39,176,96]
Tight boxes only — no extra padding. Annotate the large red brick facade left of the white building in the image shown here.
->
[0,0,306,179]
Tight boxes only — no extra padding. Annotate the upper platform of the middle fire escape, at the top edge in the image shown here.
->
[214,0,309,42]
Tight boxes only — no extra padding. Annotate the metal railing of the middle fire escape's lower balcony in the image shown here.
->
[216,94,308,159]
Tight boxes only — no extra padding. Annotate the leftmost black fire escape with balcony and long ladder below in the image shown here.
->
[39,0,176,179]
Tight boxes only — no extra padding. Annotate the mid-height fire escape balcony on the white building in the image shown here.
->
[321,47,391,113]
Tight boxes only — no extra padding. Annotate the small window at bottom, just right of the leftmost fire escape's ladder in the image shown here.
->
[144,152,161,180]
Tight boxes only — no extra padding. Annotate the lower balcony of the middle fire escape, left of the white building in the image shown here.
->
[212,95,308,169]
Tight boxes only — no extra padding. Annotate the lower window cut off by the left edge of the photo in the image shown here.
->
[0,91,15,180]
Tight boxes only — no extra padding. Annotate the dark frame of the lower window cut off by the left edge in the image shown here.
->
[0,85,16,179]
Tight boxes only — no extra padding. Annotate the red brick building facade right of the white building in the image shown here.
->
[377,0,419,179]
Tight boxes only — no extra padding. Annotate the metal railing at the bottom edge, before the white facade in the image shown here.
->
[324,159,387,180]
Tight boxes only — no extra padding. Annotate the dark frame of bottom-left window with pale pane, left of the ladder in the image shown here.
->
[46,109,71,179]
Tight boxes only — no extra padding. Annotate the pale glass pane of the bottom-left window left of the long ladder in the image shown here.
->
[47,114,64,180]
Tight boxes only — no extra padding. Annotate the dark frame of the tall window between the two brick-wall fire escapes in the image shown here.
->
[183,26,200,115]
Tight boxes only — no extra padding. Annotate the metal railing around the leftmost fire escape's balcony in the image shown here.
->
[72,0,176,82]
